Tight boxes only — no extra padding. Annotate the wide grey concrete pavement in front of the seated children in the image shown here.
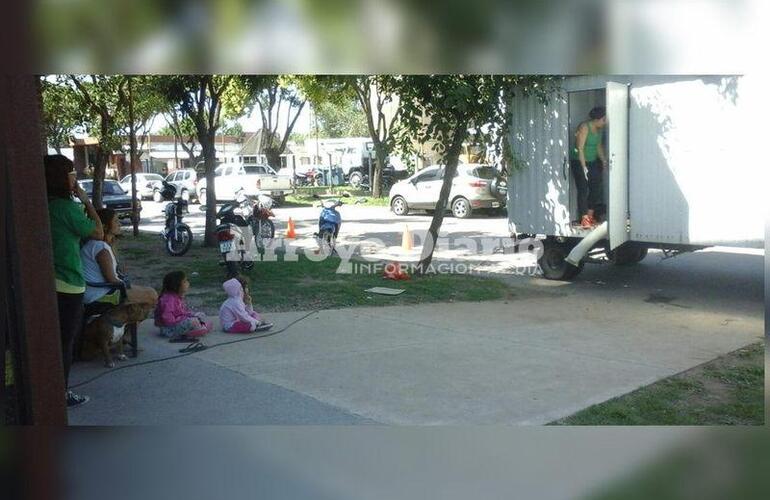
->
[70,273,764,425]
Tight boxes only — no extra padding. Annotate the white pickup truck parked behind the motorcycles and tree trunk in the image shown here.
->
[196,163,293,204]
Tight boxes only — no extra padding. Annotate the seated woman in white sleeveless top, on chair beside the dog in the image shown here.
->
[80,208,158,307]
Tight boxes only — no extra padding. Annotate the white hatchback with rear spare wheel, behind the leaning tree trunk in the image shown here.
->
[390,163,506,219]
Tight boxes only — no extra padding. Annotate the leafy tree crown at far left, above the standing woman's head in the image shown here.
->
[40,77,84,154]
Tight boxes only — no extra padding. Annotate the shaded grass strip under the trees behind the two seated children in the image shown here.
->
[118,230,511,313]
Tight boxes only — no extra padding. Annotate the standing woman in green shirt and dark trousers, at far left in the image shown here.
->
[43,155,104,407]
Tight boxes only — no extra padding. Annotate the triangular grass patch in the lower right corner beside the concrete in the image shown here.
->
[553,343,765,425]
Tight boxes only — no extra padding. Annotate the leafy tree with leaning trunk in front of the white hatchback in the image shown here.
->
[380,75,551,273]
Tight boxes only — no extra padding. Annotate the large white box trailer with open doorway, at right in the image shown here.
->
[508,76,767,279]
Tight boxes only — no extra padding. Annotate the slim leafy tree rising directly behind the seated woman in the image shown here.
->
[67,75,128,208]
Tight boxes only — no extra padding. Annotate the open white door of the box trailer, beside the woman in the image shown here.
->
[606,82,630,250]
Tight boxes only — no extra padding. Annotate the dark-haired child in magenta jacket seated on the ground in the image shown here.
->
[155,271,213,342]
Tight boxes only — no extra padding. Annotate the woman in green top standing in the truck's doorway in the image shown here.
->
[570,106,607,229]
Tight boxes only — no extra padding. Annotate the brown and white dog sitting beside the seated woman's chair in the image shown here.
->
[80,304,151,368]
